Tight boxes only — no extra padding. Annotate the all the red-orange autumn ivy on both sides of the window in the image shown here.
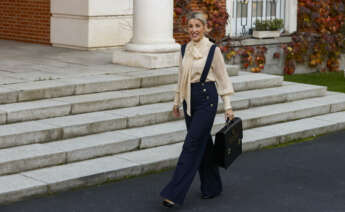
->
[174,0,345,74]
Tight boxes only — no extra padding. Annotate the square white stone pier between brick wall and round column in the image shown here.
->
[51,0,133,49]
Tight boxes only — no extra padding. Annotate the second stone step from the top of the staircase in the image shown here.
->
[0,72,282,124]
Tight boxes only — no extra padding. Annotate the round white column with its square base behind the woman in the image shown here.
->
[113,0,180,68]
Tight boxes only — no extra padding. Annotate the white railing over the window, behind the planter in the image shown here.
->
[228,0,289,37]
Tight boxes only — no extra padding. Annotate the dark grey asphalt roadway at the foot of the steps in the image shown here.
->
[0,131,345,212]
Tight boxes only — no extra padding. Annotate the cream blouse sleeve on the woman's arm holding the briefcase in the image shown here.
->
[212,47,235,110]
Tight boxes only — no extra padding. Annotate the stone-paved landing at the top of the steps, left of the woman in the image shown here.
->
[0,40,146,85]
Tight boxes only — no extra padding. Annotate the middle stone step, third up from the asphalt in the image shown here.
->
[0,84,326,148]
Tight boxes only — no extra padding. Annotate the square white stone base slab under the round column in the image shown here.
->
[113,49,180,69]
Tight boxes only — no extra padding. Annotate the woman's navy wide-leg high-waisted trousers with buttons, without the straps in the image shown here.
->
[160,81,222,205]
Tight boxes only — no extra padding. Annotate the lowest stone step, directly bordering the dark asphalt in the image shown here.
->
[0,109,345,203]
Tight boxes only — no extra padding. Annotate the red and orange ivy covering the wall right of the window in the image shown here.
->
[282,0,345,74]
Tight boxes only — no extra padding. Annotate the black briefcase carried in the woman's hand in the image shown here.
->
[213,117,243,169]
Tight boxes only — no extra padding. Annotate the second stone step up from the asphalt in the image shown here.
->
[0,94,345,175]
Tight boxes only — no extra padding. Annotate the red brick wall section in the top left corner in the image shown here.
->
[0,0,50,44]
